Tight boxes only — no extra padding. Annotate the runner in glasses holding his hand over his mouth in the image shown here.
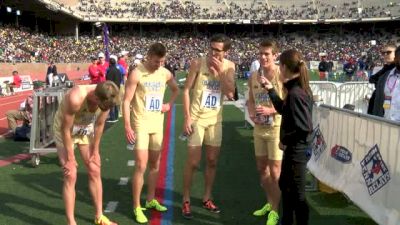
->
[182,34,235,219]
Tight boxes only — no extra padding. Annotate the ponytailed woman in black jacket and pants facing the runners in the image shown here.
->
[260,50,313,225]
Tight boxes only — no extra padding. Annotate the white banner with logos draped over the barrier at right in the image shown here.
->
[308,105,400,225]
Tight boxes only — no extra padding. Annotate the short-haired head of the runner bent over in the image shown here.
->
[94,81,120,109]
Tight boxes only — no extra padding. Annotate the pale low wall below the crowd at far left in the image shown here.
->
[0,63,90,81]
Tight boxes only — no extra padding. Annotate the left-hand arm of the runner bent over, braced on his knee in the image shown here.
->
[61,86,84,164]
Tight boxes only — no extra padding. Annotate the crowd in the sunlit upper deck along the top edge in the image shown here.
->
[74,0,400,21]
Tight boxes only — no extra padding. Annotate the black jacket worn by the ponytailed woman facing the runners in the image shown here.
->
[269,78,313,161]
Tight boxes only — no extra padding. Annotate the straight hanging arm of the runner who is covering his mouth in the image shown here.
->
[183,59,200,134]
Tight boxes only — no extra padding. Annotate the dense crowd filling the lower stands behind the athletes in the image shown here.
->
[0,26,399,71]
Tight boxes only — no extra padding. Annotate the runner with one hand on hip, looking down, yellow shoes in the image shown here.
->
[123,43,179,223]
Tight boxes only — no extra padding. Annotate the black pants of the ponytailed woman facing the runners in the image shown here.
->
[279,149,309,225]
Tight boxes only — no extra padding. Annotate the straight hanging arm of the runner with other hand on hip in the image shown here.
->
[122,69,139,143]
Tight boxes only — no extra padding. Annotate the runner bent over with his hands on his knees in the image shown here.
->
[53,81,119,225]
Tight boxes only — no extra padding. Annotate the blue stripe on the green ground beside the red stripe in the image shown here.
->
[161,105,176,225]
